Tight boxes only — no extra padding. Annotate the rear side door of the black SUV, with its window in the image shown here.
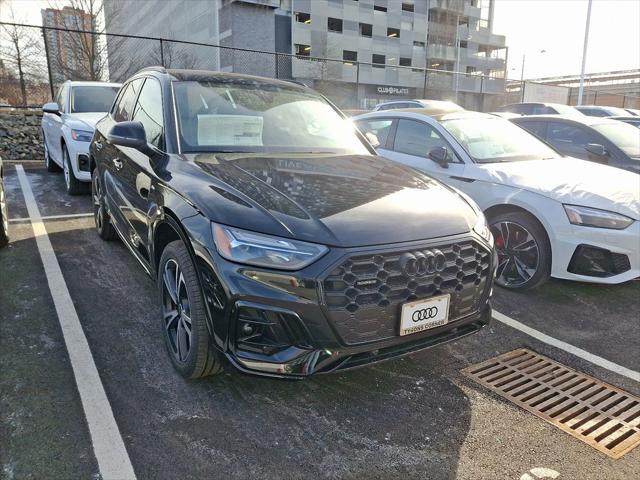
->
[101,78,144,241]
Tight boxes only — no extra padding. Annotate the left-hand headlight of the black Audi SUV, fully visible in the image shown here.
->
[213,223,329,270]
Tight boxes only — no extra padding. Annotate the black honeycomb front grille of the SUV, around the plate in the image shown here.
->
[322,240,491,345]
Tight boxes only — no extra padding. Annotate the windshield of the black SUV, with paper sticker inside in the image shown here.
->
[174,80,369,154]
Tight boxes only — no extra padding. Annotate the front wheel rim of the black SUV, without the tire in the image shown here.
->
[162,259,191,363]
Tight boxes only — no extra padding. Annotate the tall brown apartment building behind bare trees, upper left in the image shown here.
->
[41,7,95,83]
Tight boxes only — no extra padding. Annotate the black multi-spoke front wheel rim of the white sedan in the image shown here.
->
[491,221,540,288]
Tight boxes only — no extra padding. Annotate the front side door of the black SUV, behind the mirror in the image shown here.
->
[118,77,165,262]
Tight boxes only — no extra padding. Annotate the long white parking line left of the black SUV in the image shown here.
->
[15,165,136,480]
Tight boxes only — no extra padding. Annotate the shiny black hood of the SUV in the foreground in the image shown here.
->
[172,154,477,247]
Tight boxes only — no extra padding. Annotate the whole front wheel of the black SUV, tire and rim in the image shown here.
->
[157,240,222,379]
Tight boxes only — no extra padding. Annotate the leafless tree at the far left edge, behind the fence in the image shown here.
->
[0,5,42,105]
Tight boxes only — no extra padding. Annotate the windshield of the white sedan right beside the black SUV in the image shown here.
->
[442,117,559,163]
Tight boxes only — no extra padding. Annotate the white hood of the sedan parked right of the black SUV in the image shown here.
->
[478,157,640,220]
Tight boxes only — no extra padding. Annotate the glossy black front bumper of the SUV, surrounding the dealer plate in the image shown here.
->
[199,234,495,378]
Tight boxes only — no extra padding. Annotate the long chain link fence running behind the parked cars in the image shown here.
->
[0,22,640,111]
